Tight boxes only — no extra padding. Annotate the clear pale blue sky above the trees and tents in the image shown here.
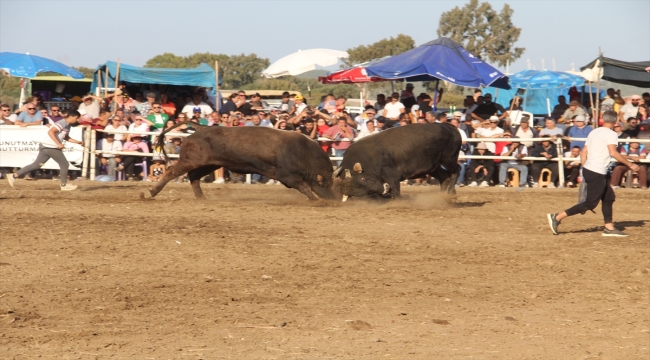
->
[0,0,650,72]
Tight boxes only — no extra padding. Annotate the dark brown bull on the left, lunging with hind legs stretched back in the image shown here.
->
[143,122,335,200]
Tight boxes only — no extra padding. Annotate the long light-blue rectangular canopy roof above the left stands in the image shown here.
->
[91,61,217,95]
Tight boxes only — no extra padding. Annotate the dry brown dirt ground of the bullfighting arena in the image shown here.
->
[0,180,650,360]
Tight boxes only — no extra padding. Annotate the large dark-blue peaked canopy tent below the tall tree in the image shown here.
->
[366,37,510,89]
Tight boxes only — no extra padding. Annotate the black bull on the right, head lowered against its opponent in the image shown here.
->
[334,124,461,201]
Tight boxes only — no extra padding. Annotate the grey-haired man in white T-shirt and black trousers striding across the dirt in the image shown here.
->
[546,110,639,236]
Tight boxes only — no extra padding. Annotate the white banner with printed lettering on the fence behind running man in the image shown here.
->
[0,125,84,170]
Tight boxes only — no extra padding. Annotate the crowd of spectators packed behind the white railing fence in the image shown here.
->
[0,84,650,189]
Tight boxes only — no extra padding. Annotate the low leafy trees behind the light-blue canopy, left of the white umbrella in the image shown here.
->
[144,53,270,89]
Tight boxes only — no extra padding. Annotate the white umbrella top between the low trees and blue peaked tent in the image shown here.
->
[262,49,350,78]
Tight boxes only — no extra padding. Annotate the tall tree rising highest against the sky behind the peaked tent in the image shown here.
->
[438,0,526,66]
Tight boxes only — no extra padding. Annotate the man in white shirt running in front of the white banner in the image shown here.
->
[7,110,83,191]
